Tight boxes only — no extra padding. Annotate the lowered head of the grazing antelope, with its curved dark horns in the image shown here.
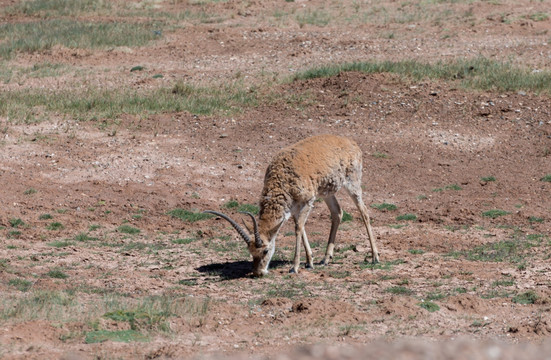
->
[203,210,275,276]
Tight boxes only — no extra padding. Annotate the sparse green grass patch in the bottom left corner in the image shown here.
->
[0,288,211,328]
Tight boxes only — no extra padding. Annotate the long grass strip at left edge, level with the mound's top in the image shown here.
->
[0,79,257,123]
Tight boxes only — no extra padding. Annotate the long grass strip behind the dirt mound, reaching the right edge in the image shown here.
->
[293,57,551,93]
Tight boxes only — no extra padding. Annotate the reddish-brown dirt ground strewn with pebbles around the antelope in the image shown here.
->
[0,0,551,359]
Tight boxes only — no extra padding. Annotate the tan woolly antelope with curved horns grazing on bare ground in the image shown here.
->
[204,135,379,276]
